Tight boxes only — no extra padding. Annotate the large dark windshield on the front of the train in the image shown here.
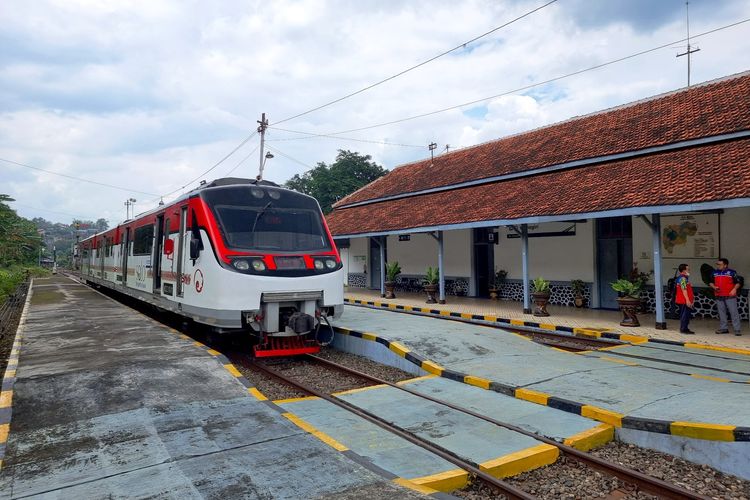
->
[206,186,331,252]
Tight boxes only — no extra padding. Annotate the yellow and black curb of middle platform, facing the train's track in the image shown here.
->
[334,327,750,441]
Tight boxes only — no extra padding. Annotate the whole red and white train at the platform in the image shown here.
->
[79,178,344,356]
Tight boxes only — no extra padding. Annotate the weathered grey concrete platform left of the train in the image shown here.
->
[0,276,432,499]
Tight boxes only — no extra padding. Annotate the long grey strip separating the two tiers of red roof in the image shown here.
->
[334,130,750,210]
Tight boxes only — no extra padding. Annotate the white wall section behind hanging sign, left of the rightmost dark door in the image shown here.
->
[495,221,596,282]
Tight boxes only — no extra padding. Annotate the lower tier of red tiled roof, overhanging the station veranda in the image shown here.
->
[327,139,750,235]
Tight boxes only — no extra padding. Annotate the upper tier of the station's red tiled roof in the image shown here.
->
[334,73,750,208]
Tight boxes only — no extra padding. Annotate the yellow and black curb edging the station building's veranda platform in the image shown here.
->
[344,298,750,356]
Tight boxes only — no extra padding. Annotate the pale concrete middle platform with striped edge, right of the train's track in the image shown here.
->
[335,306,750,478]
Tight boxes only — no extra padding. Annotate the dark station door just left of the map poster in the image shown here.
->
[596,217,633,309]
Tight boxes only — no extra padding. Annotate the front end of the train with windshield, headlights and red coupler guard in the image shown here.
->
[201,181,344,357]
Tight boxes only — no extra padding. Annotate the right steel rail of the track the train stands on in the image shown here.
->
[307,355,710,500]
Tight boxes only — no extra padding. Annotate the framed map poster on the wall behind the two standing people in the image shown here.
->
[661,214,719,259]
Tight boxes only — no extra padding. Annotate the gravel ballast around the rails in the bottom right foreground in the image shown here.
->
[453,442,750,500]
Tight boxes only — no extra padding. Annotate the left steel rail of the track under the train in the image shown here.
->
[250,359,536,500]
